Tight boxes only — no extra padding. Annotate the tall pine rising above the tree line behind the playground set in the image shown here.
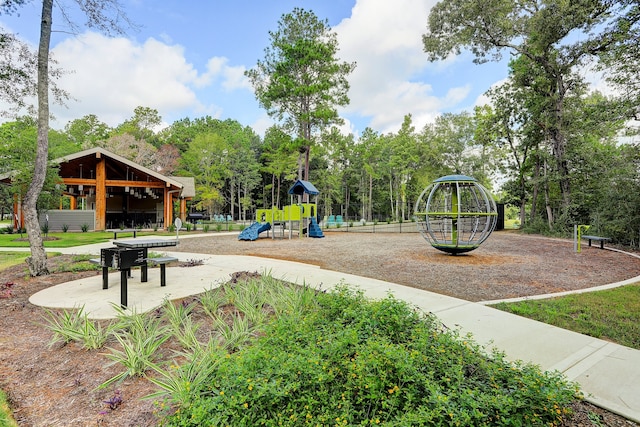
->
[246,8,355,179]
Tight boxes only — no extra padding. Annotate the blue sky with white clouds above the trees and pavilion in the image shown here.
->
[0,0,507,135]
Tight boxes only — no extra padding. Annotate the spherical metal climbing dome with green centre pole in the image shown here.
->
[415,175,498,255]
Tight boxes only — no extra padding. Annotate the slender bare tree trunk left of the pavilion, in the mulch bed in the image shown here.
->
[24,0,53,276]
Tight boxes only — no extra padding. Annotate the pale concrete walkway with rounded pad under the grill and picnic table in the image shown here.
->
[5,235,640,423]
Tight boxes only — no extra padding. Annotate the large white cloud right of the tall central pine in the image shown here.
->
[333,0,462,133]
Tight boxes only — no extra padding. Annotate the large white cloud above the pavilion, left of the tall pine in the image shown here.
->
[53,32,199,126]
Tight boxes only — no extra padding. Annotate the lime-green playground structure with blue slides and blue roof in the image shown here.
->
[238,180,324,240]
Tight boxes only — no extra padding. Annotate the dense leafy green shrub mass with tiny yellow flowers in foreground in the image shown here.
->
[164,286,580,427]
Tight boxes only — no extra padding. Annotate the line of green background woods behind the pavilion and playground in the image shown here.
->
[0,91,640,245]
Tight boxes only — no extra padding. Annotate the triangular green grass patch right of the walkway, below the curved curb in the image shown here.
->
[493,283,640,350]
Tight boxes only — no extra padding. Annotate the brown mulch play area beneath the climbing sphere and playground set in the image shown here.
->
[172,231,640,302]
